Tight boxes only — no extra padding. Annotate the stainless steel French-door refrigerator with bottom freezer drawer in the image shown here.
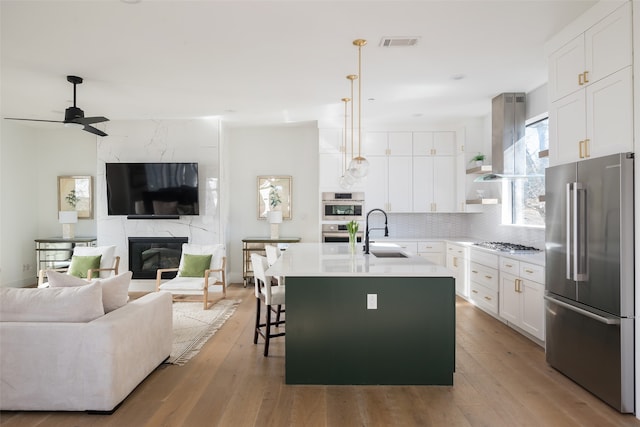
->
[545,153,635,412]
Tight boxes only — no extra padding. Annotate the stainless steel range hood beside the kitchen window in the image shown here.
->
[476,92,526,181]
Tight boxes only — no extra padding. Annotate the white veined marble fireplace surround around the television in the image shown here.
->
[95,119,224,288]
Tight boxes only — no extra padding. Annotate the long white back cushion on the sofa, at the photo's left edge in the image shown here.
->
[0,282,104,322]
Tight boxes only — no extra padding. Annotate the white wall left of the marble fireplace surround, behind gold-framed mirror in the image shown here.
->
[0,121,96,286]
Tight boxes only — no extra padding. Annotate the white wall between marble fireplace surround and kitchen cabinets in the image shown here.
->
[225,122,320,283]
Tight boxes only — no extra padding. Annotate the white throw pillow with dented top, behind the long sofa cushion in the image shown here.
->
[47,270,133,313]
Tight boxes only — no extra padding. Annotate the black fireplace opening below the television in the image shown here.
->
[129,237,189,279]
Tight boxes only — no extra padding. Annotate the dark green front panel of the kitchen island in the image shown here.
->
[286,276,455,385]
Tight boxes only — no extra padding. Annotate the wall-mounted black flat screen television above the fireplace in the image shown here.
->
[105,163,199,217]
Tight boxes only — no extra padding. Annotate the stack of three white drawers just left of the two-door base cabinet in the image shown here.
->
[469,249,499,316]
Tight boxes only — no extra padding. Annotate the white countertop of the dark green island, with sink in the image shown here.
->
[267,243,453,277]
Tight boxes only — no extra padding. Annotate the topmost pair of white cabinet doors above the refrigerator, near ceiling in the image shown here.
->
[549,2,632,102]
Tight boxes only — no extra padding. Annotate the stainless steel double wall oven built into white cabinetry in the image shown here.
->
[322,192,364,243]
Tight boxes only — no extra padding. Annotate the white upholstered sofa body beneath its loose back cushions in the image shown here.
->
[0,285,173,412]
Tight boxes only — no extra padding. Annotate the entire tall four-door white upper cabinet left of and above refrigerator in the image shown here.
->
[549,2,633,166]
